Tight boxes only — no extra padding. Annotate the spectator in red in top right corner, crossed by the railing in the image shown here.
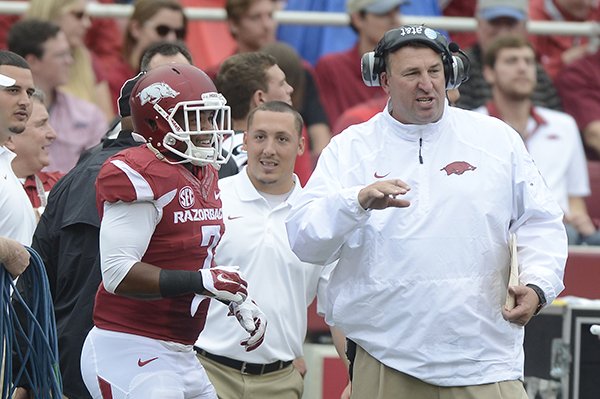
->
[529,0,600,80]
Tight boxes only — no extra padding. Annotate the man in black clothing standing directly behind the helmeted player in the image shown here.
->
[25,43,195,399]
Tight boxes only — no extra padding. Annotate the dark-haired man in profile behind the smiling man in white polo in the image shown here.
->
[215,52,313,184]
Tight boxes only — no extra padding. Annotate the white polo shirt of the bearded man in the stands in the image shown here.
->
[475,103,590,213]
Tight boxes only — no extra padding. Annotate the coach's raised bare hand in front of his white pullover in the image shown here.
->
[358,179,410,209]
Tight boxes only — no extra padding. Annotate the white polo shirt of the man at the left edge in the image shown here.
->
[0,146,37,246]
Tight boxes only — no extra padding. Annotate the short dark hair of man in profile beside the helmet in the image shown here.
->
[215,52,277,119]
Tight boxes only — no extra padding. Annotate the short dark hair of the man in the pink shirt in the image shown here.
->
[7,19,60,58]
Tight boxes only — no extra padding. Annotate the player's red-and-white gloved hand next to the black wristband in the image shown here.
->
[200,266,248,304]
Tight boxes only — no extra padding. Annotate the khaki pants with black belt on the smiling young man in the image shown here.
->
[197,355,304,399]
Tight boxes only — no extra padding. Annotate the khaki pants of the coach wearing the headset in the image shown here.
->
[351,346,527,399]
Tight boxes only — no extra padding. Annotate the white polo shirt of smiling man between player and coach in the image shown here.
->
[196,167,329,364]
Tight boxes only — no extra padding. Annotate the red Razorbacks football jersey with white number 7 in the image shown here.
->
[94,145,224,345]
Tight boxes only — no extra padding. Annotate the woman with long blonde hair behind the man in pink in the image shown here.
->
[26,0,114,120]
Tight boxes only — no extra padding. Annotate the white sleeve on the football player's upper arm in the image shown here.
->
[100,201,160,294]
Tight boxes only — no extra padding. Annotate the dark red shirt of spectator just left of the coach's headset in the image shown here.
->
[315,44,385,126]
